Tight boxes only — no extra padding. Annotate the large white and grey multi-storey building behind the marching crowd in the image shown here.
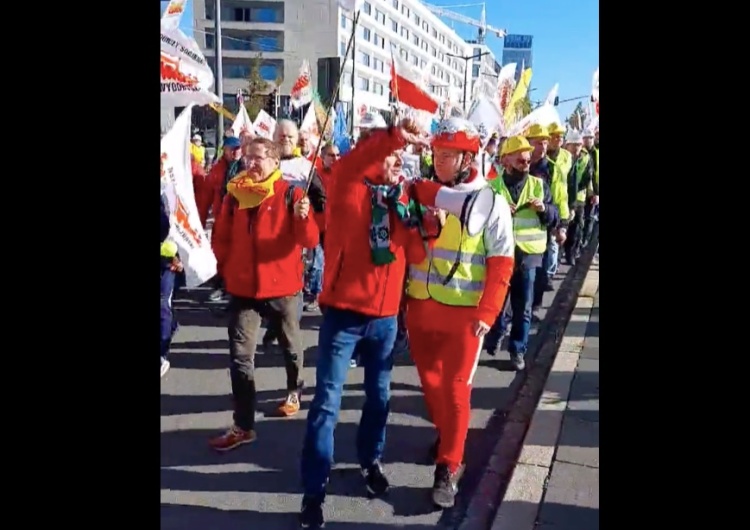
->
[193,0,473,112]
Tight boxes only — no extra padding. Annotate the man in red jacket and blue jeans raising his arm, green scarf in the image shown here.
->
[300,120,425,528]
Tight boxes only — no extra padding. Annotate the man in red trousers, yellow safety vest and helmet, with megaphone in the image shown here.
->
[406,118,514,508]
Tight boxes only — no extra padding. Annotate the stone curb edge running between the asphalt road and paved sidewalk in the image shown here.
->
[457,234,598,530]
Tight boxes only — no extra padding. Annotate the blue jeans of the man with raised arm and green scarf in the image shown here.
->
[301,307,397,497]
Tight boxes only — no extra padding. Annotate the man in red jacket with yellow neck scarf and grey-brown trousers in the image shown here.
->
[210,138,318,451]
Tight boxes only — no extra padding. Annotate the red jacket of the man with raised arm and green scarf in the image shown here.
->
[318,129,425,317]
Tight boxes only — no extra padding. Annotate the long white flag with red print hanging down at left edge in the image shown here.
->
[161,104,216,288]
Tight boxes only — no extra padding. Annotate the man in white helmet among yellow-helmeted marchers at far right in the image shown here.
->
[564,129,593,265]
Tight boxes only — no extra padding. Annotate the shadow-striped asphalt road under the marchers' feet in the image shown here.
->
[161,260,568,530]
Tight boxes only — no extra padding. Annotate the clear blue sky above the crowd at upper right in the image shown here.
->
[427,0,599,119]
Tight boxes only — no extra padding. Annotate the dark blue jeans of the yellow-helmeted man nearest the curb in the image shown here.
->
[486,264,537,357]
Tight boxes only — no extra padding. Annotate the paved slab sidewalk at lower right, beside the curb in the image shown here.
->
[491,260,599,530]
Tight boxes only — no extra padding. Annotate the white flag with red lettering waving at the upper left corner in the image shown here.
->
[160,26,221,107]
